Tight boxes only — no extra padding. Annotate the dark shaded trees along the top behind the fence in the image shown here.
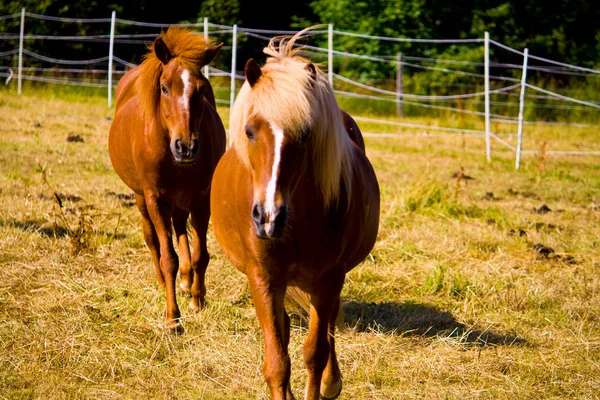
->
[0,0,600,90]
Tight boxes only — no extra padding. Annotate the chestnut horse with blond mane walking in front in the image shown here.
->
[211,31,380,399]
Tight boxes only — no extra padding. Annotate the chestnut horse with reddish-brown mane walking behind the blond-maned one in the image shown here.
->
[108,28,226,331]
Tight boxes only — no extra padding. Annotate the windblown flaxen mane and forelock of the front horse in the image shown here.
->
[230,28,353,205]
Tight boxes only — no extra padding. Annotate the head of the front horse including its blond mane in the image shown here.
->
[230,32,354,239]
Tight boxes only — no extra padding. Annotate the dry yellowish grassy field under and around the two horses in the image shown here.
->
[0,89,600,400]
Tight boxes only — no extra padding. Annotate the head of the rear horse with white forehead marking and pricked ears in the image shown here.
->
[153,36,222,164]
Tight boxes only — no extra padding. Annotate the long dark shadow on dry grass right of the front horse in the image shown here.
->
[343,301,527,346]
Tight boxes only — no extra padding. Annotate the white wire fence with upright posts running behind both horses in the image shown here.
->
[0,9,600,169]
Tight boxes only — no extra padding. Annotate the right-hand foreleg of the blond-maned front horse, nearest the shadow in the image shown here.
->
[304,275,344,400]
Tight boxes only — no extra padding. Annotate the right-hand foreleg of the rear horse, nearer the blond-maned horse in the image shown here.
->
[191,200,210,310]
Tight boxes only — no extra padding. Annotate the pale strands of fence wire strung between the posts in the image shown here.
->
[0,12,600,162]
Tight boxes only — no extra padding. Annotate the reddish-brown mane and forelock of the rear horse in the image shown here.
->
[135,27,217,115]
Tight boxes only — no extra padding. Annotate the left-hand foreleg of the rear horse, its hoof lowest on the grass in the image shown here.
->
[145,193,183,333]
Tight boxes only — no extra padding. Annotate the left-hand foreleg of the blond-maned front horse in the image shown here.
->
[248,269,294,400]
